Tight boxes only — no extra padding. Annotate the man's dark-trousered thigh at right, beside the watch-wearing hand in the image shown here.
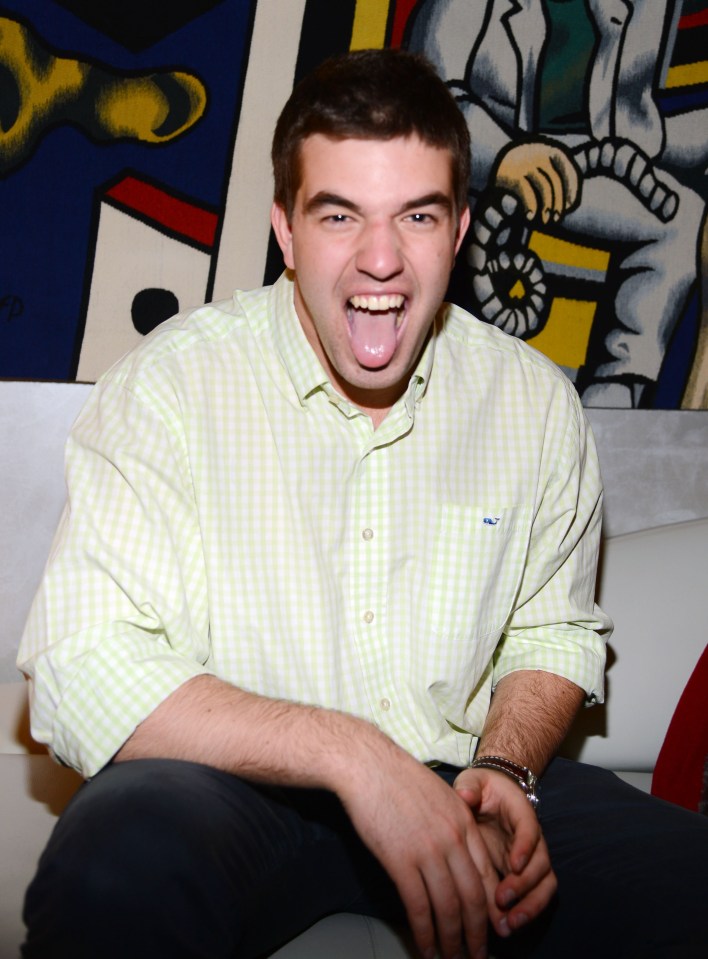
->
[499,759,708,959]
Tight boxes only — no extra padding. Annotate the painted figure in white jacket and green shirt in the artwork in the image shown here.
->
[408,0,705,408]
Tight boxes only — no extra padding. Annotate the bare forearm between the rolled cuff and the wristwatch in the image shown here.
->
[477,670,585,775]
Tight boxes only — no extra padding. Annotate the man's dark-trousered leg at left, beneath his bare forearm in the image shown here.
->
[23,760,398,959]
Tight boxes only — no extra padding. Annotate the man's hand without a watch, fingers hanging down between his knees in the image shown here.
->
[340,747,504,959]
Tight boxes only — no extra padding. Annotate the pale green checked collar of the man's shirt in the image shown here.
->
[271,271,444,419]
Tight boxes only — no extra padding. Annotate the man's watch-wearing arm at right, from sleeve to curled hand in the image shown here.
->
[455,391,610,929]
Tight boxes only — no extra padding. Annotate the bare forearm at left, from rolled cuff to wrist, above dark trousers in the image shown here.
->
[115,676,404,792]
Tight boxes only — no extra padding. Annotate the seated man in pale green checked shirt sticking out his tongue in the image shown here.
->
[20,51,708,959]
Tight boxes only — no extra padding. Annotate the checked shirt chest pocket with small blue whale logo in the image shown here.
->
[428,503,531,639]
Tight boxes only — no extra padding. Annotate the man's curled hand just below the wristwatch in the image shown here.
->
[454,769,557,936]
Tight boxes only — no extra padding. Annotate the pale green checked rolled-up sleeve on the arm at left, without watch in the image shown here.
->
[18,377,209,777]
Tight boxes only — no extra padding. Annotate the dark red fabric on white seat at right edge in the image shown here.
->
[651,646,708,812]
